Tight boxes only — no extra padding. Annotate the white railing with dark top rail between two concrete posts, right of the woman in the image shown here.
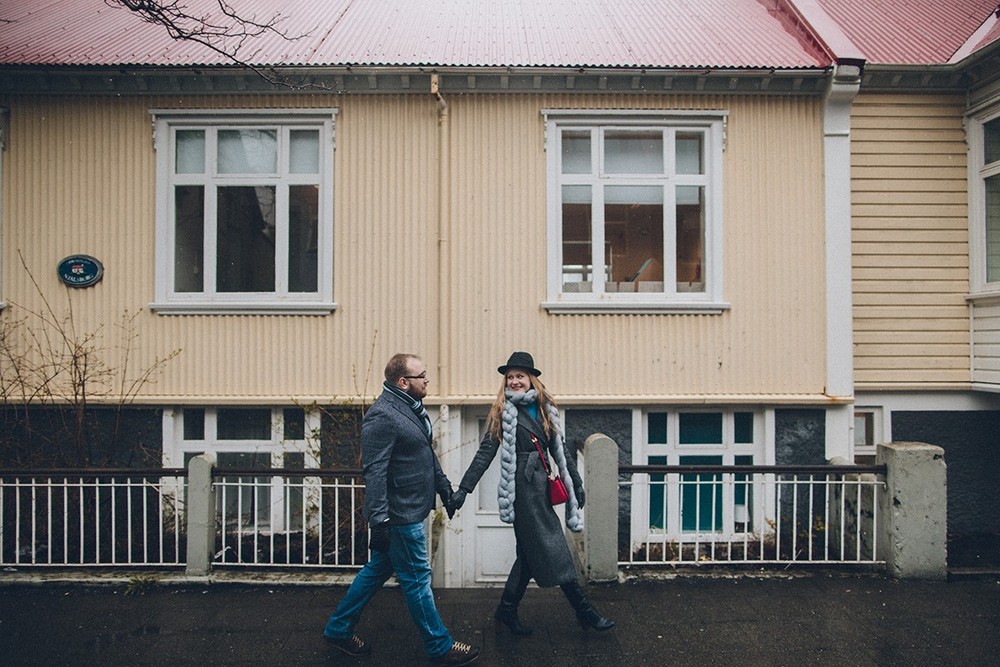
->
[618,465,886,566]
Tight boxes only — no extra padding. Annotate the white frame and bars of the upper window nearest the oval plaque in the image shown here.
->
[150,109,337,315]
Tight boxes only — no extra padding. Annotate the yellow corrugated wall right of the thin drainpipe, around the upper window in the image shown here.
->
[452,95,825,400]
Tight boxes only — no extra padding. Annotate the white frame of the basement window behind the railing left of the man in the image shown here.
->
[163,406,322,533]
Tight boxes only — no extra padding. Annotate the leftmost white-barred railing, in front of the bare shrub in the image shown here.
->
[0,468,187,567]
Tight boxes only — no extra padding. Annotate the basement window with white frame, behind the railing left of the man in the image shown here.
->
[164,407,320,532]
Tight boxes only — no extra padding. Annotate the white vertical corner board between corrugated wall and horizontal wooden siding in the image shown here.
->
[823,59,864,460]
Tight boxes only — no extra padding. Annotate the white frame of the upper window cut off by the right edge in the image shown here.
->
[966,104,1000,298]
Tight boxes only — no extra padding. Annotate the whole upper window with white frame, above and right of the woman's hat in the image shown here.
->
[545,111,725,312]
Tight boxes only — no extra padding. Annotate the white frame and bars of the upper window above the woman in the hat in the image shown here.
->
[542,109,729,313]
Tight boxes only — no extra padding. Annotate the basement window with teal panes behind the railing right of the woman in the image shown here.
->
[632,410,764,537]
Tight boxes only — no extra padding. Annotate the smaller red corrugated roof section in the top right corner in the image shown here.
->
[817,0,998,65]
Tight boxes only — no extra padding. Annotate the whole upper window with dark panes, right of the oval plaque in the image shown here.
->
[153,110,335,314]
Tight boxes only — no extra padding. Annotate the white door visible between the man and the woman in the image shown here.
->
[455,411,515,587]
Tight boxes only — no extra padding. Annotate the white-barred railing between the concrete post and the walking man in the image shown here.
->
[212,469,368,568]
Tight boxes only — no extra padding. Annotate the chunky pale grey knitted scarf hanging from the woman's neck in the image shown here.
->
[497,389,583,533]
